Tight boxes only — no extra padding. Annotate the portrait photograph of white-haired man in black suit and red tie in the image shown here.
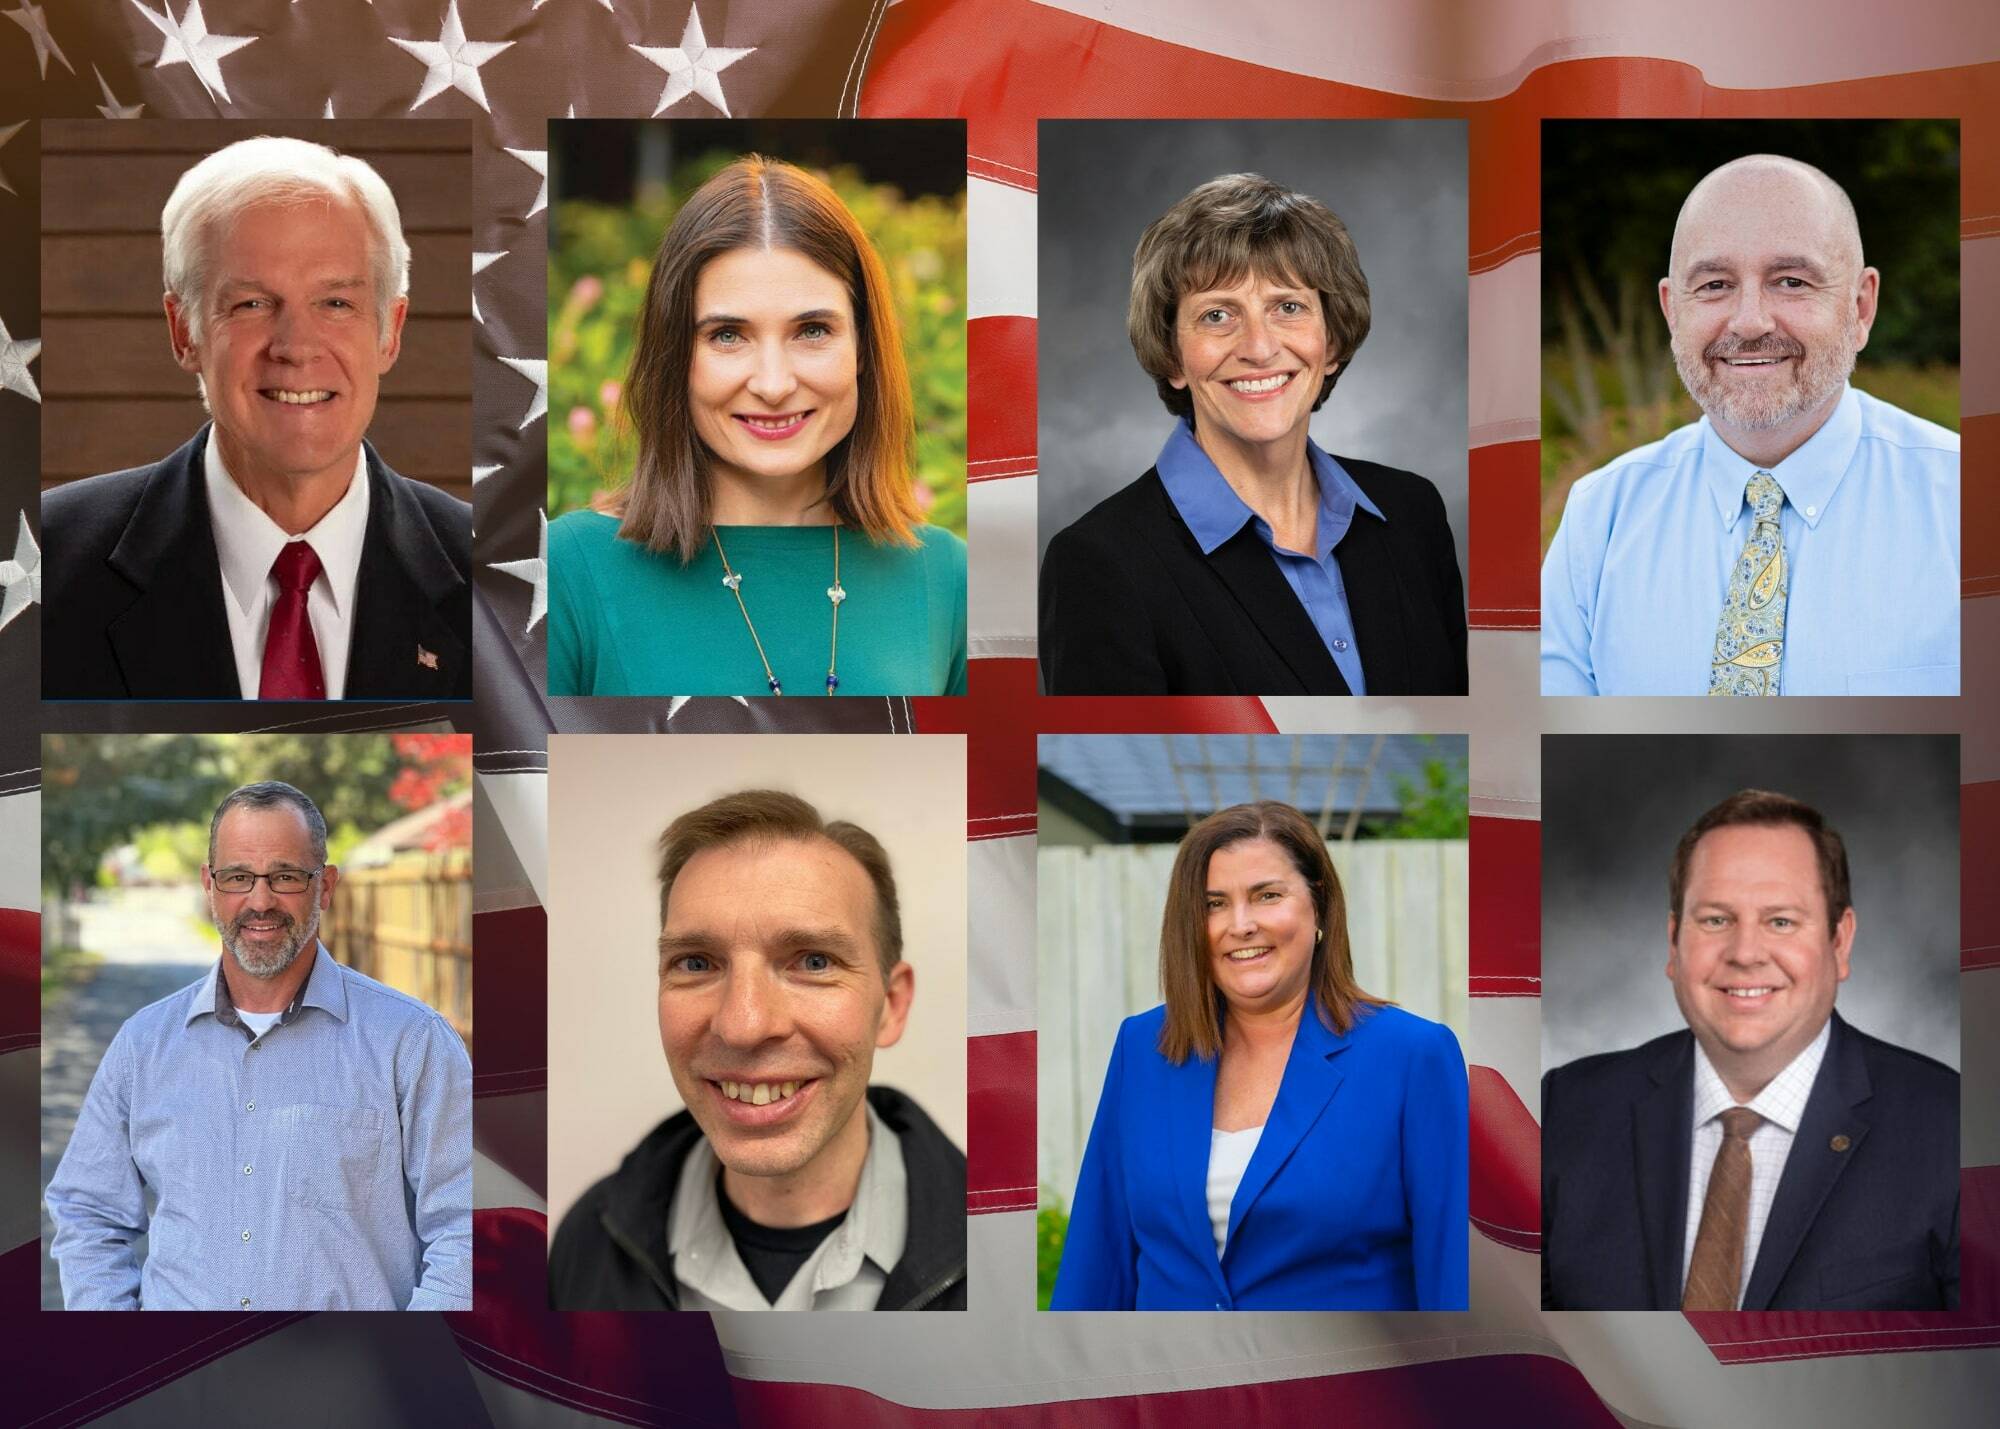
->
[40,120,474,700]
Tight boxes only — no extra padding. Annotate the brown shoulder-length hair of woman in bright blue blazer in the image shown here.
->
[1160,799,1388,1065]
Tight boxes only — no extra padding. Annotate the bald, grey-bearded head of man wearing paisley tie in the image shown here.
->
[1660,160,1880,440]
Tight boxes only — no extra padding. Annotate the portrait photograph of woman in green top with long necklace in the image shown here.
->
[548,120,966,696]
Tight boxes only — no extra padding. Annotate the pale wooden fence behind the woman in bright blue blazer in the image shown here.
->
[1036,839,1466,1209]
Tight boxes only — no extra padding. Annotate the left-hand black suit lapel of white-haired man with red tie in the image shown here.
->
[104,426,242,700]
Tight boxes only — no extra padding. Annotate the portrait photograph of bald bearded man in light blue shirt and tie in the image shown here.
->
[1540,118,1962,696]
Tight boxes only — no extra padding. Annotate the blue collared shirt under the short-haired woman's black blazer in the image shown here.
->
[1154,418,1384,694]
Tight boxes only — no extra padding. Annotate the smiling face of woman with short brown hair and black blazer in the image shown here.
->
[1168,272,1340,452]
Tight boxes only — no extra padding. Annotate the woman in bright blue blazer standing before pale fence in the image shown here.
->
[1050,803,1466,1309]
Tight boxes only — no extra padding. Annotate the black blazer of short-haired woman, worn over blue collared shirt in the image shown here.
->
[1040,456,1466,694]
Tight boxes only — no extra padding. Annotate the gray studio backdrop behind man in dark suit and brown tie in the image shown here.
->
[1542,735,1960,1071]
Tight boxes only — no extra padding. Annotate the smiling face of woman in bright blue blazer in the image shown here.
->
[1208,839,1318,1013]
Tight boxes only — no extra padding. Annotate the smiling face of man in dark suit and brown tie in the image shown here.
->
[1666,825,1854,1101]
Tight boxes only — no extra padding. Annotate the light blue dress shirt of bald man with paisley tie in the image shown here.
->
[1542,388,1960,694]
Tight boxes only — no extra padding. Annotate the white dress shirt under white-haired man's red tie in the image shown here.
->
[202,428,368,700]
